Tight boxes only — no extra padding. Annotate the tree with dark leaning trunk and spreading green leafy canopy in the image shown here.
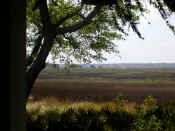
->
[26,0,174,98]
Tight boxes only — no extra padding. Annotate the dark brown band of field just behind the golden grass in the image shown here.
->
[32,80,175,102]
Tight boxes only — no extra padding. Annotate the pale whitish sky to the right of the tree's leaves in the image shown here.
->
[105,5,175,63]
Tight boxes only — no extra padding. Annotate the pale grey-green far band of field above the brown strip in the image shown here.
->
[39,68,175,83]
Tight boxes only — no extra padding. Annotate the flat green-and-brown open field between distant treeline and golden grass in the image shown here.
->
[32,69,175,102]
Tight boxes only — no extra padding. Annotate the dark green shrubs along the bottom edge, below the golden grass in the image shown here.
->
[26,95,175,131]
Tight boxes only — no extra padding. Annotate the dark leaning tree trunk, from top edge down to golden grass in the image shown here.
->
[26,0,57,98]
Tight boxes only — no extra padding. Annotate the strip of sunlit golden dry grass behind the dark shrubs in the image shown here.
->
[26,94,136,113]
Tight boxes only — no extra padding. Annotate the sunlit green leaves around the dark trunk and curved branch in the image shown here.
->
[27,0,148,63]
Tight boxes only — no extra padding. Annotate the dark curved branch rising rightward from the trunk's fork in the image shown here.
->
[57,6,101,34]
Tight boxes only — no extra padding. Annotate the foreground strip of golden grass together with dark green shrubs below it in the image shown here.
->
[26,94,175,131]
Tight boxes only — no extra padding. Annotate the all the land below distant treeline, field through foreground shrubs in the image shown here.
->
[26,69,175,131]
